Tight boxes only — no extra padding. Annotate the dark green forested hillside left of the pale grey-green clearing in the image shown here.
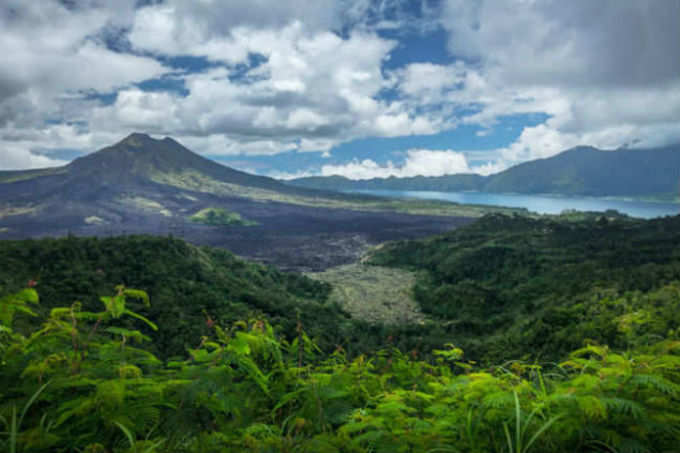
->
[0,236,370,357]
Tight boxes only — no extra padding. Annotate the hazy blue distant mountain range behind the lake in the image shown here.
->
[287,145,680,200]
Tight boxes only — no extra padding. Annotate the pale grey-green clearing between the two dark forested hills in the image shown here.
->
[307,263,424,324]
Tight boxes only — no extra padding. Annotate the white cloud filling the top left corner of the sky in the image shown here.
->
[0,0,167,107]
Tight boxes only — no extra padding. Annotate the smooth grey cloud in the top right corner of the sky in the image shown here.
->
[442,0,680,88]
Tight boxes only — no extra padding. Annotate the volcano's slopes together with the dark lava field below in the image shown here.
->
[0,134,469,270]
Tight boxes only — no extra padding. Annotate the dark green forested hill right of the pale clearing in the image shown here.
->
[371,215,680,363]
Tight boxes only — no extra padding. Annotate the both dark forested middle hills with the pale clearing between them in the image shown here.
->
[6,215,680,363]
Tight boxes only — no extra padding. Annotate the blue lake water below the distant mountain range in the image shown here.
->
[352,190,680,219]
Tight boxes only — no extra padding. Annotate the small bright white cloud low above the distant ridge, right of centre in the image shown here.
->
[321,149,472,179]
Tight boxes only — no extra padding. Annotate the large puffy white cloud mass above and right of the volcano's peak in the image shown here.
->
[93,22,444,154]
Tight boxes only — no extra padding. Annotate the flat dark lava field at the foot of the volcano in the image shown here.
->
[0,192,472,271]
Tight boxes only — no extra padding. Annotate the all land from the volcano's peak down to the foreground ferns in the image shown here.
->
[0,134,680,453]
